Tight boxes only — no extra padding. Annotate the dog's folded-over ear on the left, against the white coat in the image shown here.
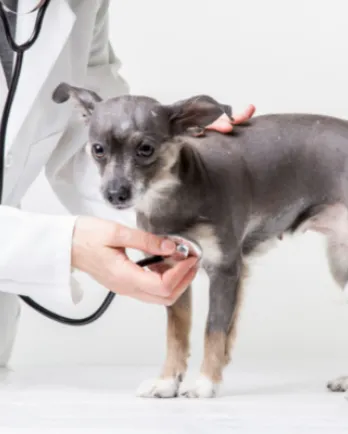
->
[52,83,102,121]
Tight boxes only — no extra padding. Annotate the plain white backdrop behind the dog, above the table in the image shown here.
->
[8,0,348,374]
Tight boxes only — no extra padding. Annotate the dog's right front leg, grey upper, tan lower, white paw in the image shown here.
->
[180,261,244,398]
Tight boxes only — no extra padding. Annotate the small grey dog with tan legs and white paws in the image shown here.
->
[53,83,348,398]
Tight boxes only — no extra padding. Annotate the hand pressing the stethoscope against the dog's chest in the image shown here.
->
[72,217,198,306]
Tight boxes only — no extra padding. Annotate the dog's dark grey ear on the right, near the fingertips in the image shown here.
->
[165,95,232,135]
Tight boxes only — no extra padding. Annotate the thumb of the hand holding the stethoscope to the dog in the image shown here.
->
[110,225,176,256]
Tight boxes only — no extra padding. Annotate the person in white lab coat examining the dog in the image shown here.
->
[0,0,251,366]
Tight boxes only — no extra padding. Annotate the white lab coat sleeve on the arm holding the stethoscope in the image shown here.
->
[0,206,75,304]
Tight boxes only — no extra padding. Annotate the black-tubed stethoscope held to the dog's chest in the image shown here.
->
[0,0,202,326]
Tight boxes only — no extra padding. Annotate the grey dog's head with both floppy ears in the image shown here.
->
[53,83,231,209]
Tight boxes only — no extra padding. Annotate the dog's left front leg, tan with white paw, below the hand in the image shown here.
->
[137,288,191,398]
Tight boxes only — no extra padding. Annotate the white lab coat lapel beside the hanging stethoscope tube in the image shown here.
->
[6,0,76,149]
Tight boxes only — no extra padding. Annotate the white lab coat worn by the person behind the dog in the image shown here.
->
[0,0,133,362]
